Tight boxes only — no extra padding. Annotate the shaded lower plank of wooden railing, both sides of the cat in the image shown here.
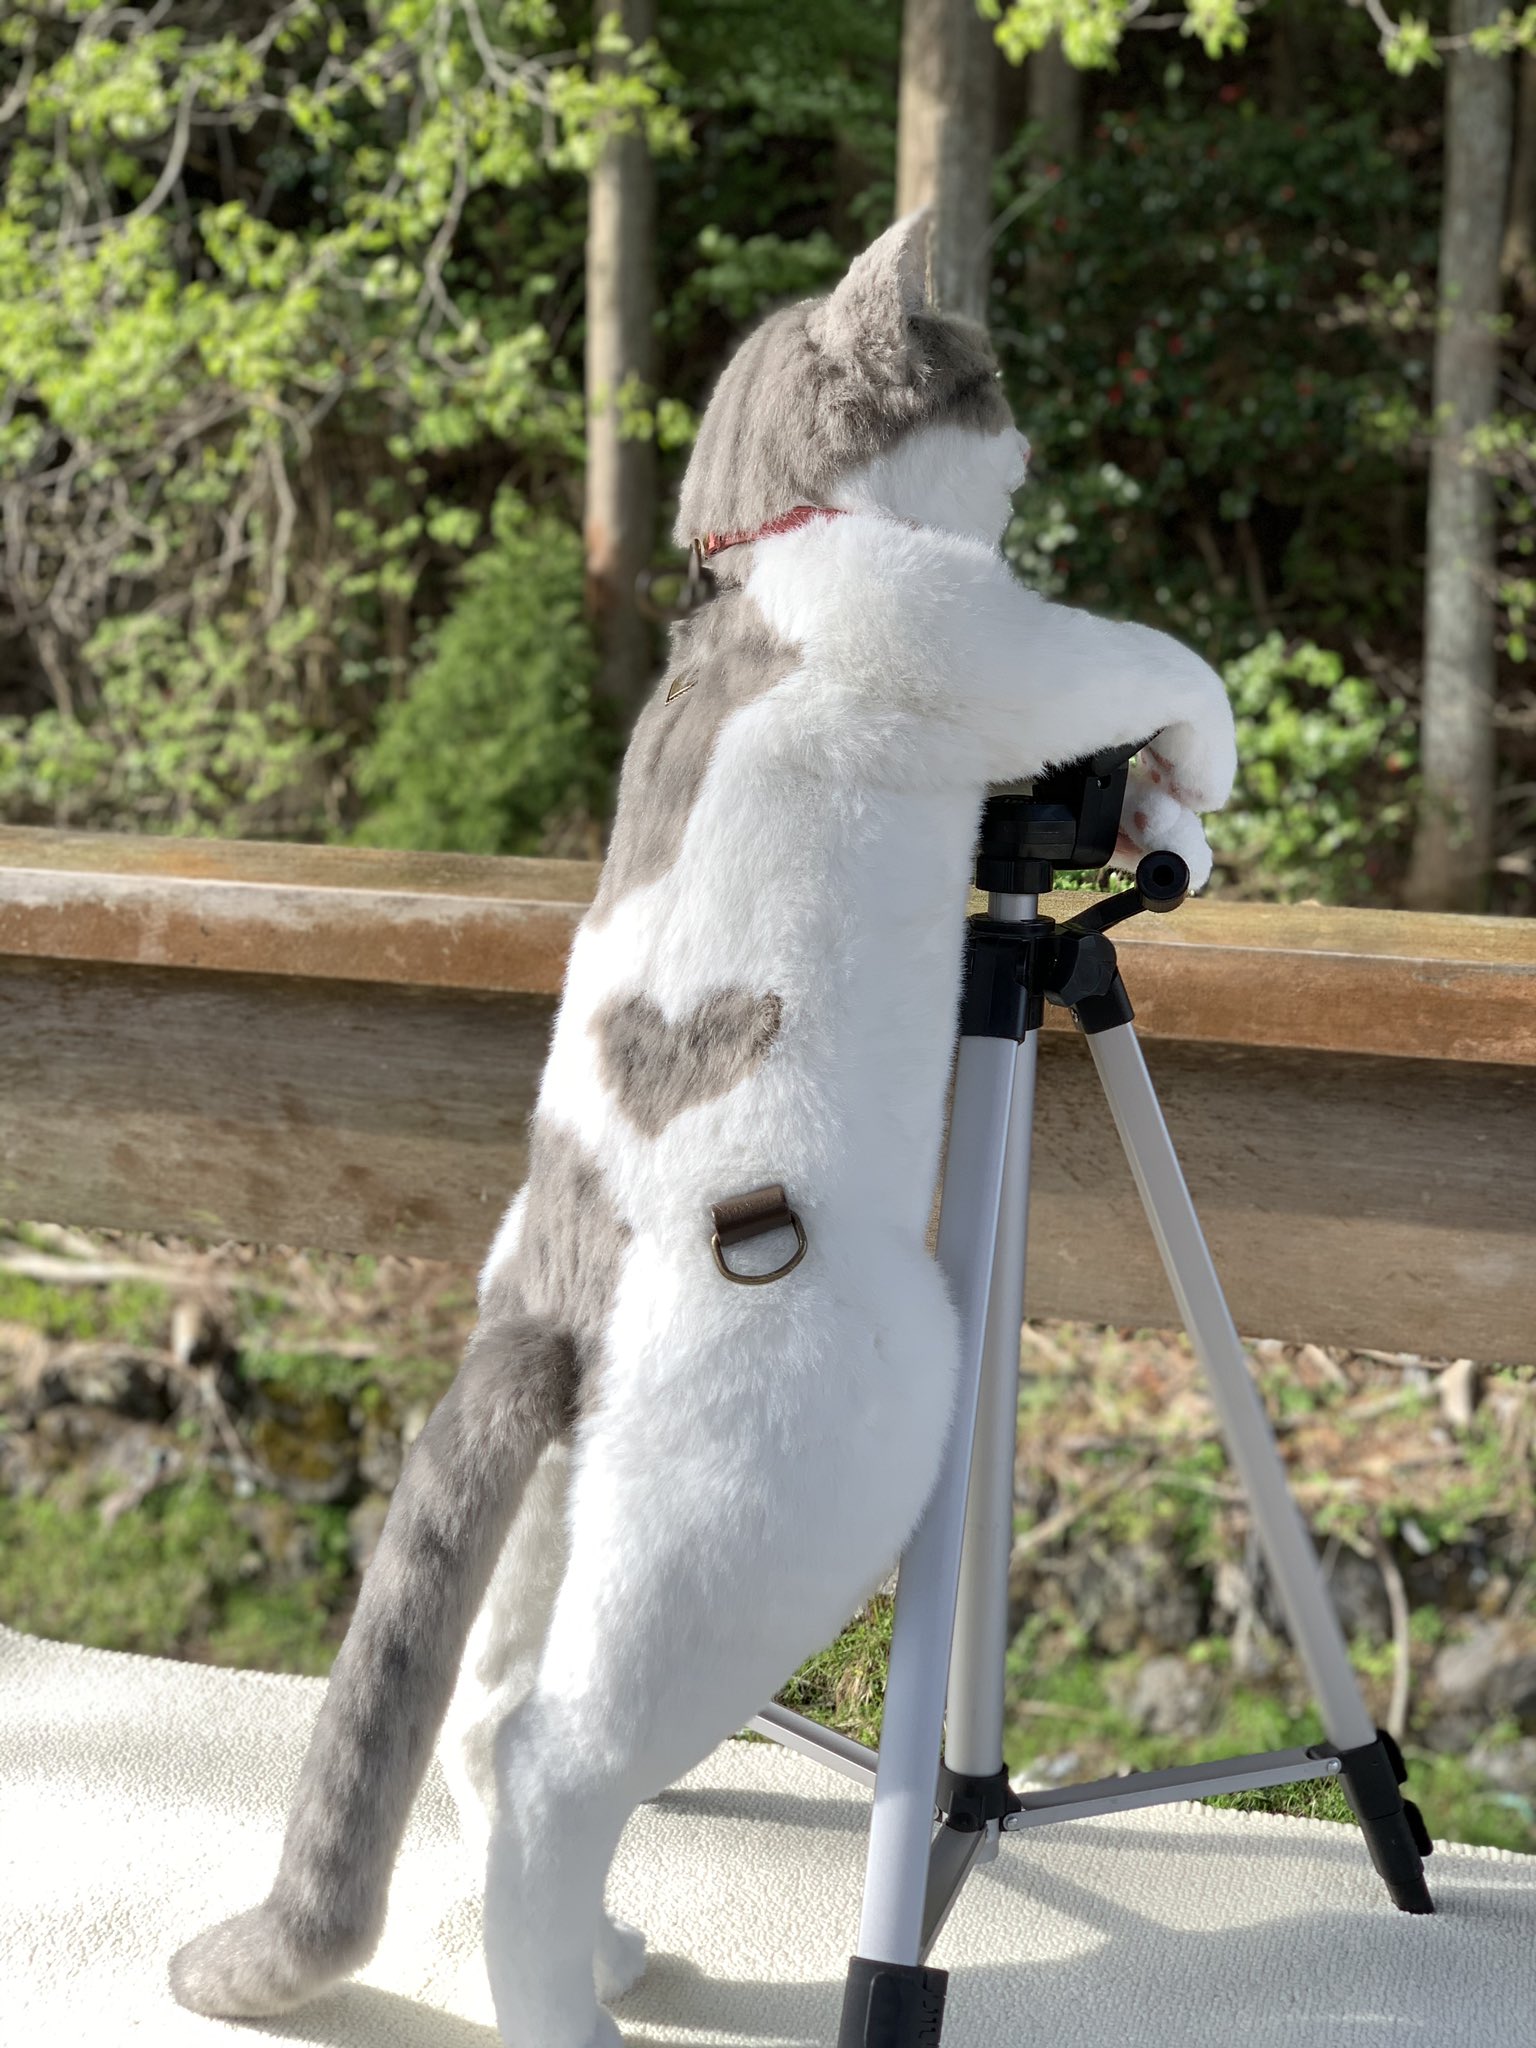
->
[0,961,1536,1364]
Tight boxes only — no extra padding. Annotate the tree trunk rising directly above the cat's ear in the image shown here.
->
[897,0,995,322]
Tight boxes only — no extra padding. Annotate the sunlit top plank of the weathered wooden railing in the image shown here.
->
[0,827,1536,1065]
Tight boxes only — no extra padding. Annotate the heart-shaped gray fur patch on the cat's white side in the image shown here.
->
[592,989,784,1139]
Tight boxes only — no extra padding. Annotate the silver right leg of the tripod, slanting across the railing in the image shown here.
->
[1087,1024,1376,1749]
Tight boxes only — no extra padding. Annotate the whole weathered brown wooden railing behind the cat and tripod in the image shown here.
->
[0,829,1536,1362]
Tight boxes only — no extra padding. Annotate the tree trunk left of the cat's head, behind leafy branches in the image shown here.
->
[586,0,655,731]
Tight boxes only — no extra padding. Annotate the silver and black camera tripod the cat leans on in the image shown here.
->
[752,748,1434,2048]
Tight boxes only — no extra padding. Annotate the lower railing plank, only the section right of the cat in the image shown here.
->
[1028,1036,1536,1364]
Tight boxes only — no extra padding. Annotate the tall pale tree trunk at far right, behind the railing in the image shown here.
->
[1407,0,1513,909]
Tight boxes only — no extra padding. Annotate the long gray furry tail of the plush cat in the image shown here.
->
[170,1284,578,2017]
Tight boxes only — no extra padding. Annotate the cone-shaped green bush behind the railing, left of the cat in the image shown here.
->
[356,492,602,854]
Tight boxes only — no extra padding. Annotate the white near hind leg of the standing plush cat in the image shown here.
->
[485,1245,954,2048]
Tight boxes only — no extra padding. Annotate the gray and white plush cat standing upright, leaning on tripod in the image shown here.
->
[170,215,1235,2048]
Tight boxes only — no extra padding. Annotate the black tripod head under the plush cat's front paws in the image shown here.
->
[977,739,1190,922]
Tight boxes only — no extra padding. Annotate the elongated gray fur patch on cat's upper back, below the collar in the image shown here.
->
[588,590,801,924]
